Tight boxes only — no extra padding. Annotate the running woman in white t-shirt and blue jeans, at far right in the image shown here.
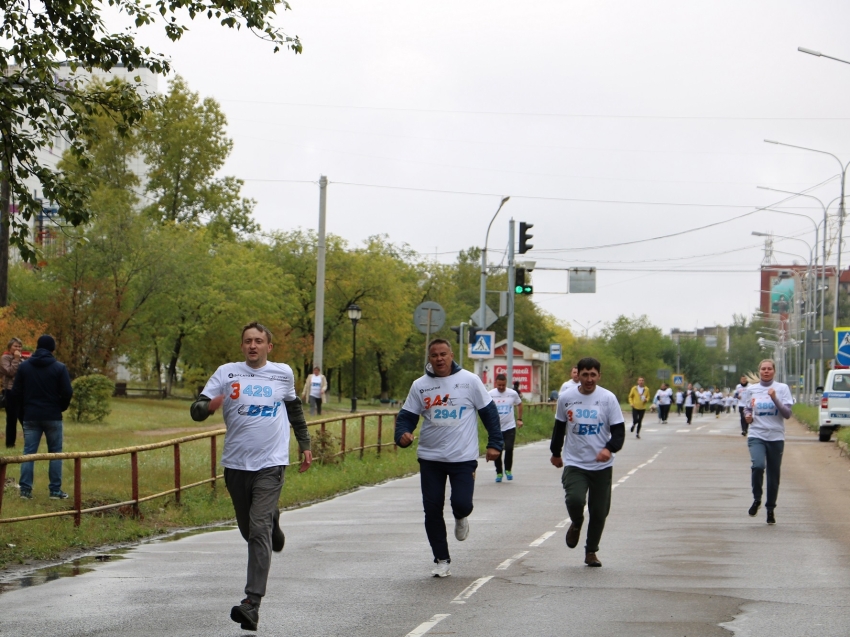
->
[744,359,794,524]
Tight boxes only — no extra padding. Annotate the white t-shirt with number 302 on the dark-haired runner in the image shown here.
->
[555,385,625,471]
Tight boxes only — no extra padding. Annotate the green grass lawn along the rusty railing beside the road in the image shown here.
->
[0,398,553,569]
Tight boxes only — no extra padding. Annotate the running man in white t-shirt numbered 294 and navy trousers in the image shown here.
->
[395,338,504,577]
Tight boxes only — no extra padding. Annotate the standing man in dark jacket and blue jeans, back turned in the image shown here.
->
[12,334,73,500]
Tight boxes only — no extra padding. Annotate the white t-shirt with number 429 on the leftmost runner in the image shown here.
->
[201,363,298,471]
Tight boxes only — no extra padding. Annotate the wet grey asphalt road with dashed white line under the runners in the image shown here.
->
[0,408,850,637]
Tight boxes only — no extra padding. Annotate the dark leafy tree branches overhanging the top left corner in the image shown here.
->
[0,0,301,258]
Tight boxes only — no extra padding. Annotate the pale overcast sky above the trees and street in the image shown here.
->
[136,0,850,332]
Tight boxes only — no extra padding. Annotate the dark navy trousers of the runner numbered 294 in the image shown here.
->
[419,458,478,562]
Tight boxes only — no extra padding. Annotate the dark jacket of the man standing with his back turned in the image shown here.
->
[12,349,74,421]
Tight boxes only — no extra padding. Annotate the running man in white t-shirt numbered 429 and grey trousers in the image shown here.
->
[191,322,313,630]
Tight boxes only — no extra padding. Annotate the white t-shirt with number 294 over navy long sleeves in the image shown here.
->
[402,369,494,462]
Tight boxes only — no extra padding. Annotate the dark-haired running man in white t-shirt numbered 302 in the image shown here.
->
[549,357,626,566]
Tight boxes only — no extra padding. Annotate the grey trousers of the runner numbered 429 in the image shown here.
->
[224,466,286,606]
